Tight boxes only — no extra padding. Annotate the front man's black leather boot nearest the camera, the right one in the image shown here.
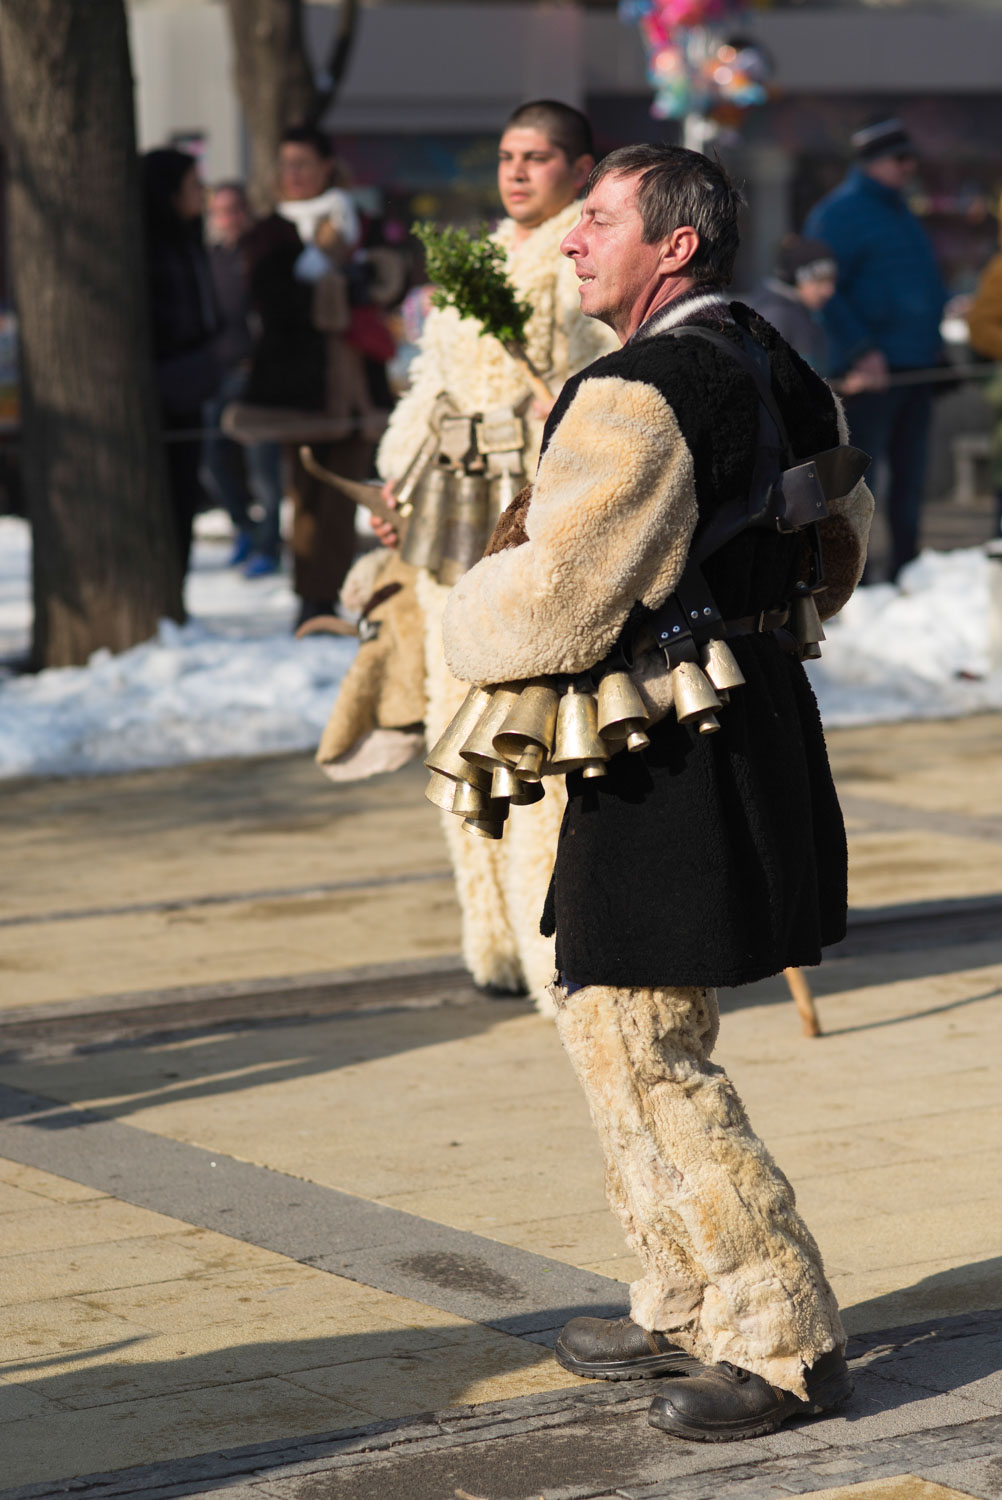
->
[647,1349,852,1443]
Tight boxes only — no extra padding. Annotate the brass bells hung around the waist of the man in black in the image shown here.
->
[425,587,825,839]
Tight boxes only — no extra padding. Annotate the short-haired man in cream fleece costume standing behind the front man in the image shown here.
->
[375,101,615,1010]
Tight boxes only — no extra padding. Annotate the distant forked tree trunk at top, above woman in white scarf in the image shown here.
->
[227,0,359,212]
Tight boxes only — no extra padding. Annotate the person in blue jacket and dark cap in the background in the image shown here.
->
[804,120,947,579]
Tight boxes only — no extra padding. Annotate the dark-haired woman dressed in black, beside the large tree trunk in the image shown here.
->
[143,149,221,578]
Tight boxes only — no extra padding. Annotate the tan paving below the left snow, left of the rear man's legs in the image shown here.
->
[0,755,459,1010]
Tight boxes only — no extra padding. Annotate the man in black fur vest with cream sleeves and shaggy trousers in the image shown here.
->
[444,146,873,1440]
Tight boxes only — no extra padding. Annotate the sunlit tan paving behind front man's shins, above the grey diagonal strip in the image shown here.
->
[0,941,1002,1331]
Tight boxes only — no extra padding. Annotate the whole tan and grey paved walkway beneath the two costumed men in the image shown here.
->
[0,717,1002,1500]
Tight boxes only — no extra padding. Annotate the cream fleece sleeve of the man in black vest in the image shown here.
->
[443,377,696,684]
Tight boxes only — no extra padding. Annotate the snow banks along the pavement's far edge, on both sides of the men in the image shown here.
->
[0,513,1002,777]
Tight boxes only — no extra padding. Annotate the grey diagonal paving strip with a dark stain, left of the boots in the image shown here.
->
[0,1085,623,1334]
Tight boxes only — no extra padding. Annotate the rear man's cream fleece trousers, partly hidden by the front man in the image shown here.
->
[417,572,567,1014]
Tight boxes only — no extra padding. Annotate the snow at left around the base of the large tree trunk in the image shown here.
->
[0,518,356,777]
